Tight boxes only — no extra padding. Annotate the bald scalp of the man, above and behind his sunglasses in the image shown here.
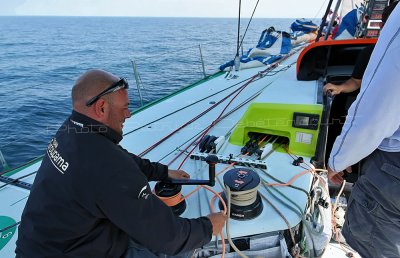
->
[72,70,119,111]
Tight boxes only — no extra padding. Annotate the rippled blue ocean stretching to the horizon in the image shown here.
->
[0,17,316,171]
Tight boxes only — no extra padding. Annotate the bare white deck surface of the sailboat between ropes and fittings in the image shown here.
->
[0,47,358,257]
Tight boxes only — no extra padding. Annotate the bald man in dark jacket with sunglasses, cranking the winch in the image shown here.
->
[16,70,226,258]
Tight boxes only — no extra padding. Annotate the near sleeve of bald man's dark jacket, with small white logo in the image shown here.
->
[97,164,212,255]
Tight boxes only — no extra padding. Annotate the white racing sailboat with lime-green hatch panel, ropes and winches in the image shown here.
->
[0,1,388,257]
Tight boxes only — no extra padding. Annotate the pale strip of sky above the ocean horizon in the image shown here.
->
[0,0,335,18]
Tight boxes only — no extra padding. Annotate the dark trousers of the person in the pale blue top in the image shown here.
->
[342,150,400,258]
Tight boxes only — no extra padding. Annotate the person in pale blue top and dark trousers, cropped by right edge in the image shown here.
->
[328,2,400,258]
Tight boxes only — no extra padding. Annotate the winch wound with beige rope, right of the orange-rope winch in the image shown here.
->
[219,168,263,220]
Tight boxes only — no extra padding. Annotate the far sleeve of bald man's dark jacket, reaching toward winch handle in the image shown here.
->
[120,146,168,181]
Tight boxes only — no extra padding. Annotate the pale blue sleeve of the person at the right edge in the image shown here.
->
[329,19,400,172]
